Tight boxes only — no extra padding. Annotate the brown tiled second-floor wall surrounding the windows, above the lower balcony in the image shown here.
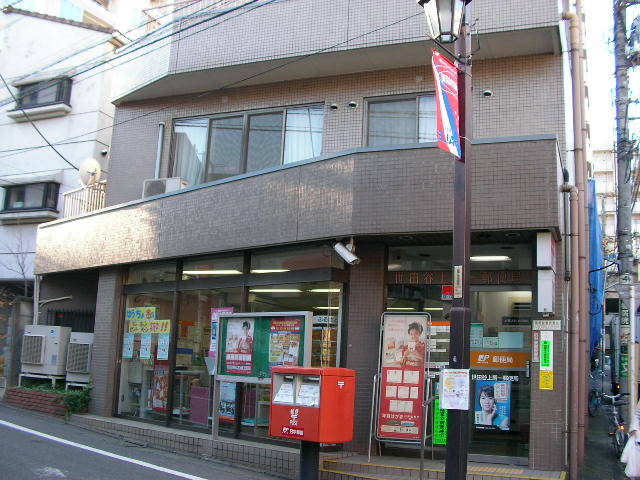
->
[106,55,565,205]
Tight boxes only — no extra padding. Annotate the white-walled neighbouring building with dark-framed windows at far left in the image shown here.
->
[0,0,170,392]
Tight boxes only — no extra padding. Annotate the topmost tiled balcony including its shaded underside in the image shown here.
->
[114,0,563,101]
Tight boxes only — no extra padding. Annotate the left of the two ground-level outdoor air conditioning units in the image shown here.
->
[20,325,71,375]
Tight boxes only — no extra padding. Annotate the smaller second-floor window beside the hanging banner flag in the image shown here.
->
[367,95,436,147]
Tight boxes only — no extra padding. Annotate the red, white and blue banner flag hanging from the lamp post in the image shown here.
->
[431,49,462,158]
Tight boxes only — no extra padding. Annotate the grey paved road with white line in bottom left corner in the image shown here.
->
[0,404,276,480]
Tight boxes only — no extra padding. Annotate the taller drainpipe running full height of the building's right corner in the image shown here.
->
[562,0,589,465]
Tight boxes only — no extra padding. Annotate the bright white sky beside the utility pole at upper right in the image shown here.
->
[583,0,640,148]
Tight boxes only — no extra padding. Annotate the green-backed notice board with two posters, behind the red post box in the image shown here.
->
[217,312,313,383]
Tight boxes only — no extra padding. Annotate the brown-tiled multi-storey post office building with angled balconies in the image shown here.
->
[36,0,574,470]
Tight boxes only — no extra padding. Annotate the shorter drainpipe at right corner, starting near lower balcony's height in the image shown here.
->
[560,183,580,480]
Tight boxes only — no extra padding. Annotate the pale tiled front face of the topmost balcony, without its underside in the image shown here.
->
[114,0,560,98]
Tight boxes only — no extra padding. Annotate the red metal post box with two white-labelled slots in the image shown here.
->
[269,367,356,443]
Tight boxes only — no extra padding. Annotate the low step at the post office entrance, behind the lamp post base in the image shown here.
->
[321,455,566,480]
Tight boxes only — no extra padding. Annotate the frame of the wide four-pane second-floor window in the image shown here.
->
[169,102,326,185]
